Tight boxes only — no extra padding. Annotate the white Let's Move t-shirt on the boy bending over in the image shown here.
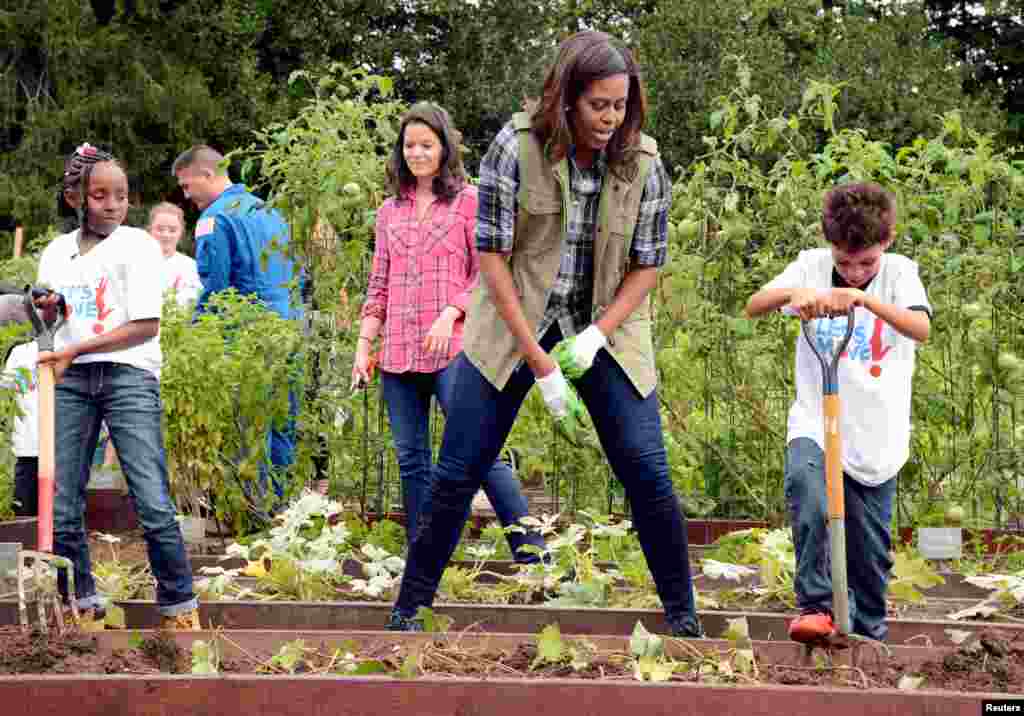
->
[765,249,932,487]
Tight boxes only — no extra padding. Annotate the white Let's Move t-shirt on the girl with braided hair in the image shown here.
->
[39,226,164,377]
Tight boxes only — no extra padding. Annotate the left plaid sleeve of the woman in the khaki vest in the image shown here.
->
[476,122,519,253]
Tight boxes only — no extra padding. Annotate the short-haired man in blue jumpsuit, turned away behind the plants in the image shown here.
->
[171,144,302,510]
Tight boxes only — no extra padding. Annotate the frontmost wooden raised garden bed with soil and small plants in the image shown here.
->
[0,631,1024,716]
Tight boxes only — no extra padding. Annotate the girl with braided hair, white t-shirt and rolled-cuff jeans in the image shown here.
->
[36,144,199,629]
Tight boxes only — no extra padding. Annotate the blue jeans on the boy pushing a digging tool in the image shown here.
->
[785,437,896,641]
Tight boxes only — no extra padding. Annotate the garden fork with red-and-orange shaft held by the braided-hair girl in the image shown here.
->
[0,285,78,633]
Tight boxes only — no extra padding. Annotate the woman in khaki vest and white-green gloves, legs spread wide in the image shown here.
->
[388,32,701,636]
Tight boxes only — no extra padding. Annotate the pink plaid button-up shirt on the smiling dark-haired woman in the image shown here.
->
[362,184,480,373]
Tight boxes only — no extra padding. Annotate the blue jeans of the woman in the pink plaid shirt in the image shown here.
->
[381,360,544,562]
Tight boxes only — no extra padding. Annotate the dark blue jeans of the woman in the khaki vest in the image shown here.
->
[395,327,699,633]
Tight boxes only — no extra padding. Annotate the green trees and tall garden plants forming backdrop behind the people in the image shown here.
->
[0,0,1024,523]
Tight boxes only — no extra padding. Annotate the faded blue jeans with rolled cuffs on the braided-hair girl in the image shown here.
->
[53,363,197,616]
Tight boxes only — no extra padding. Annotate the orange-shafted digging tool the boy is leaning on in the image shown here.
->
[785,307,854,646]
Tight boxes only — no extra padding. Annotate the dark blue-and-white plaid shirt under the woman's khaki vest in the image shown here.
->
[476,122,672,338]
